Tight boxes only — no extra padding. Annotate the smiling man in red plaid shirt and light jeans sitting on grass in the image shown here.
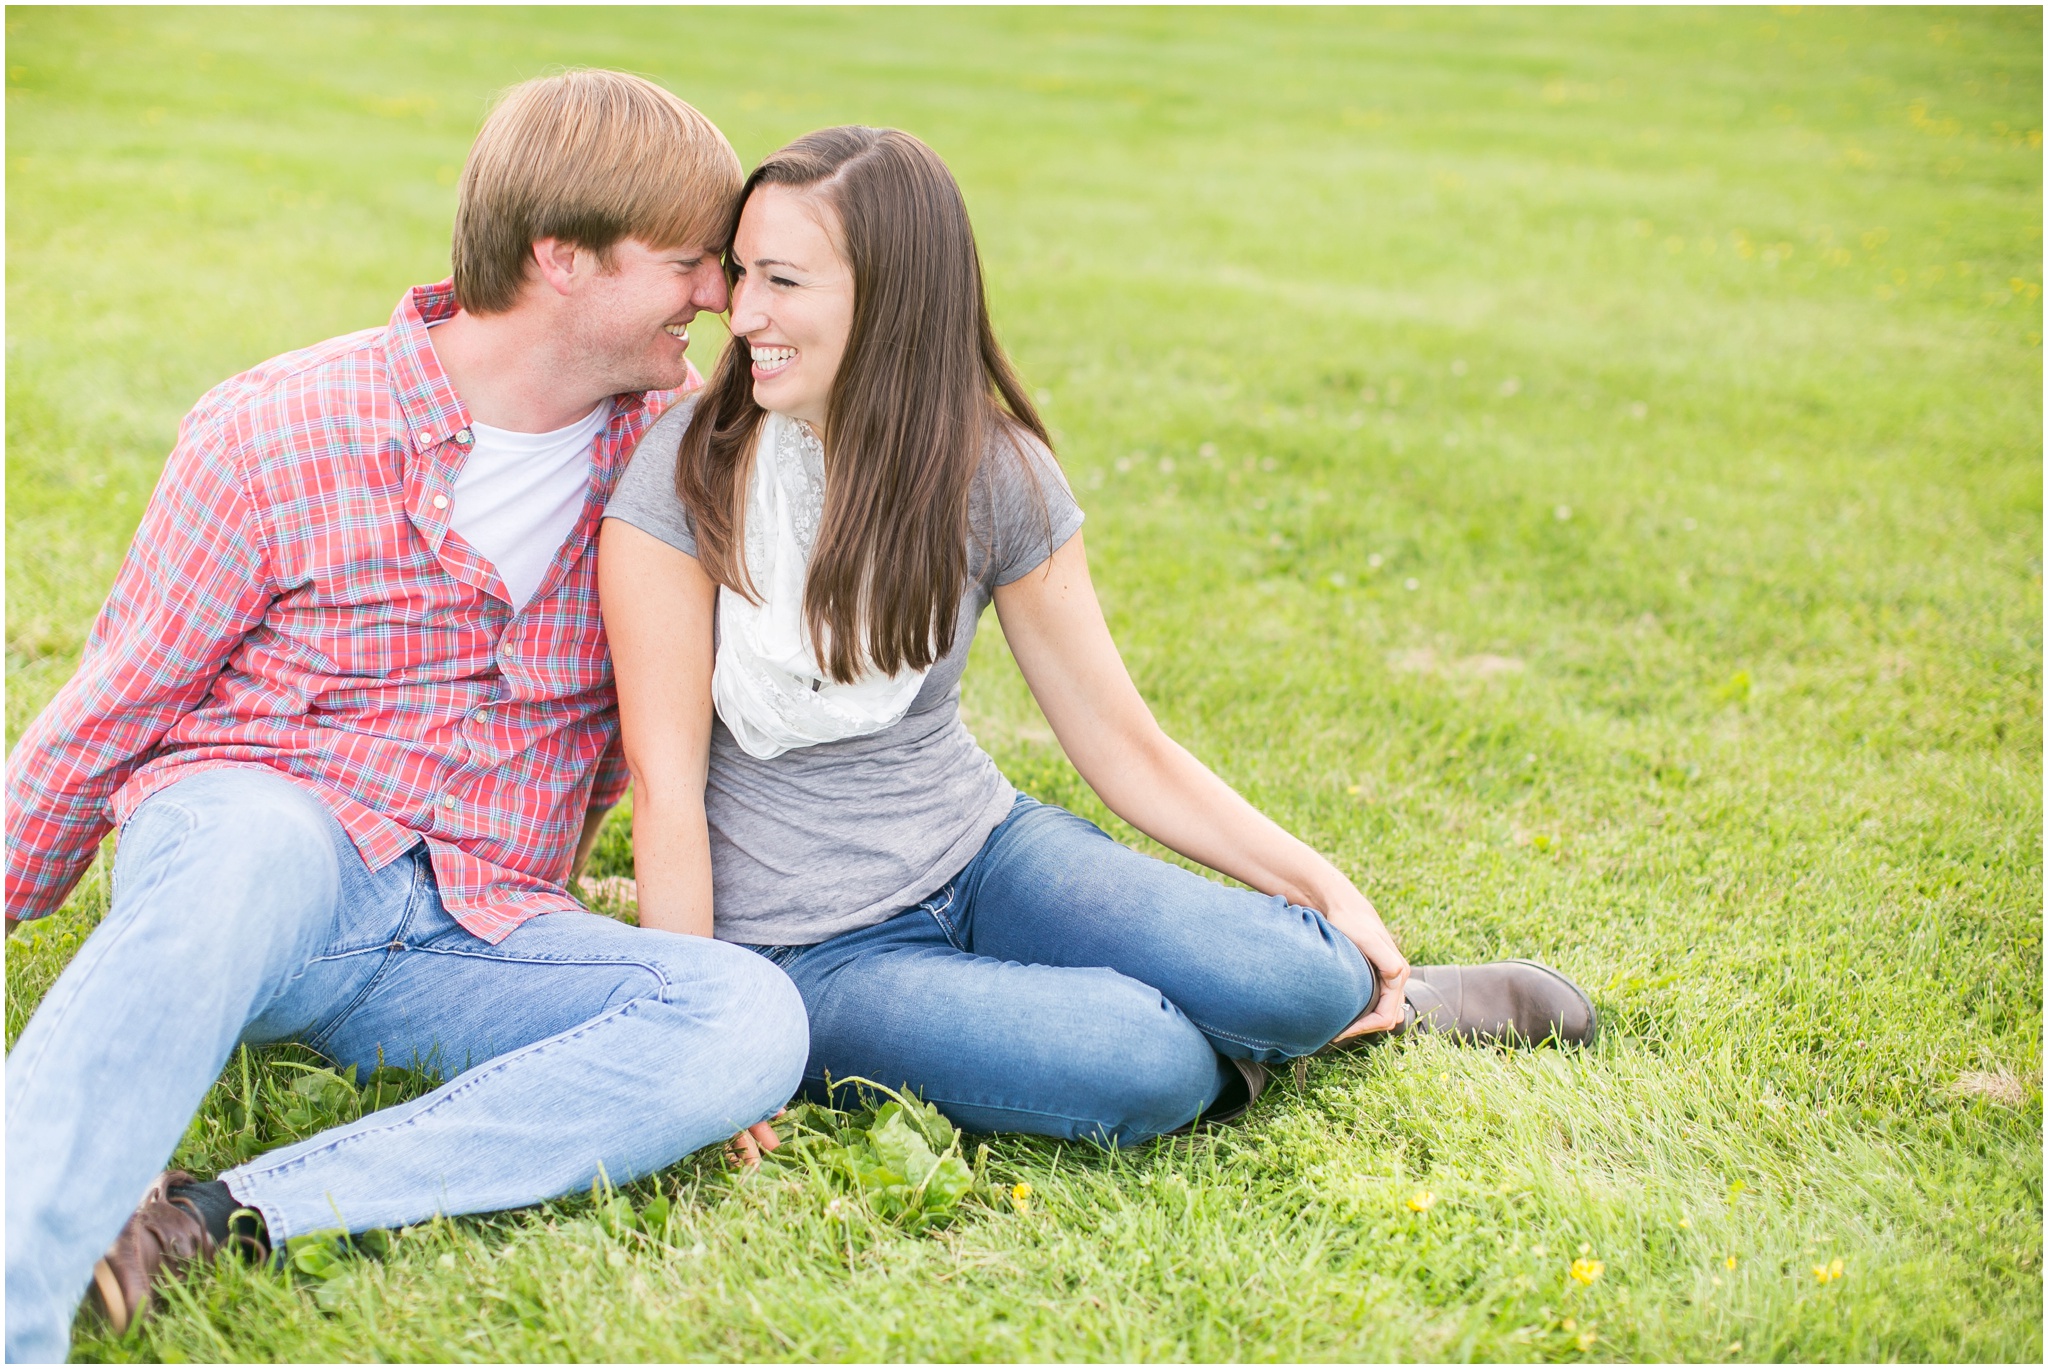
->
[6,72,807,1361]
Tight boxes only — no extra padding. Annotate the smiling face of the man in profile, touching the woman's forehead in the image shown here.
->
[565,238,725,393]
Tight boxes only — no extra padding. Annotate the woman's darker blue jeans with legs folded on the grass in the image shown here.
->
[756,795,1376,1146]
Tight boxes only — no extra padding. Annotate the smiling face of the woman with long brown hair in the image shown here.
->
[731,184,854,430]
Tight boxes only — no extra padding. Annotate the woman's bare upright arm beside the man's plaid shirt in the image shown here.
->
[598,518,719,937]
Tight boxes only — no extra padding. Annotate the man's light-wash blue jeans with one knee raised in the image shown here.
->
[6,769,807,1361]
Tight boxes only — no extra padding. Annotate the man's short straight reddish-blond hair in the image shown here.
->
[453,70,741,314]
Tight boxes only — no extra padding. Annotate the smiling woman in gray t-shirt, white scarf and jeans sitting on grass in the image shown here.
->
[600,127,1593,1146]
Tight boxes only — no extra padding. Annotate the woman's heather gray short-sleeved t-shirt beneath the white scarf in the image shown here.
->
[604,402,1081,945]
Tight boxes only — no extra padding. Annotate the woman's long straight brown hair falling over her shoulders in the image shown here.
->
[676,125,1051,682]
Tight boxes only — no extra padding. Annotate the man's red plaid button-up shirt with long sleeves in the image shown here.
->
[6,283,694,943]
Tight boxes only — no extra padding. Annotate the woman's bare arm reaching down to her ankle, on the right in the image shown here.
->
[995,533,1407,1039]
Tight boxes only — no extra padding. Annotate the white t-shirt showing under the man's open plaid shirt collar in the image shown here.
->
[449,400,612,613]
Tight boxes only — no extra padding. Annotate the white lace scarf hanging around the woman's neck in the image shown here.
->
[711,412,926,760]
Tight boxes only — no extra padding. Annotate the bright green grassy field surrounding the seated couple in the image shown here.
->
[6,8,2042,1363]
